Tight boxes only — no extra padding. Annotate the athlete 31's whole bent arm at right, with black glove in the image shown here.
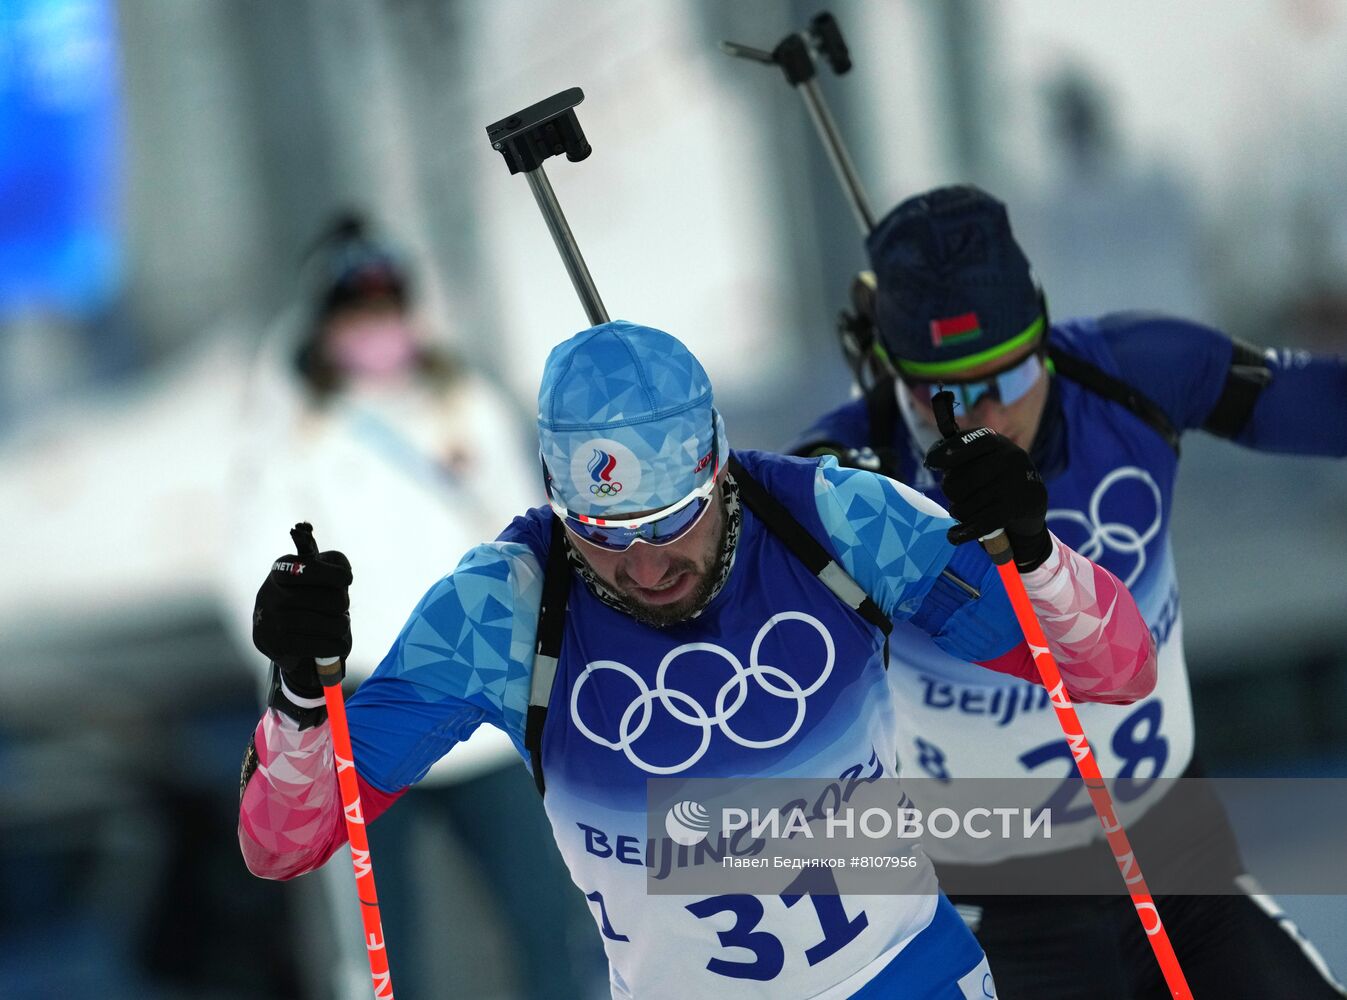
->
[816,429,1156,704]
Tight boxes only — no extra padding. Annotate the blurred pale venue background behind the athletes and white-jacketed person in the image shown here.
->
[0,0,1347,997]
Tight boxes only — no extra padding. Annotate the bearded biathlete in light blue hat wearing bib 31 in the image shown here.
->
[238,321,1154,1000]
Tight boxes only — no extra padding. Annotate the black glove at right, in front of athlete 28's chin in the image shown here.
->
[925,394,1052,573]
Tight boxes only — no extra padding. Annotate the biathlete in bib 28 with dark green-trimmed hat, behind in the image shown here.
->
[792,186,1347,1000]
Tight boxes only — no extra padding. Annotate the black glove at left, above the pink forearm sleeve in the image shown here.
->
[253,523,352,724]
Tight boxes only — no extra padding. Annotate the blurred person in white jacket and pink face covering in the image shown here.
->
[220,214,605,1000]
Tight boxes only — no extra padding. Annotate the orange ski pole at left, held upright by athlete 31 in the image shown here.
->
[290,524,393,1000]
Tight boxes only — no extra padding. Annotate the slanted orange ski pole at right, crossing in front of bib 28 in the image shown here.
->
[933,391,1192,1000]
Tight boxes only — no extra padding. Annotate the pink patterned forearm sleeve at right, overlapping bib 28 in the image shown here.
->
[983,535,1156,705]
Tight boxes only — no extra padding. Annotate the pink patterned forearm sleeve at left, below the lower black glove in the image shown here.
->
[238,709,401,879]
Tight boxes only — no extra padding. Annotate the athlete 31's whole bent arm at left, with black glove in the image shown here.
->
[238,543,541,879]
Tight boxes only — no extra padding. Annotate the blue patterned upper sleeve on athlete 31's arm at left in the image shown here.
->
[346,542,543,792]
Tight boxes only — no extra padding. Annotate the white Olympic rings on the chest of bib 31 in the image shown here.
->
[571,611,836,775]
